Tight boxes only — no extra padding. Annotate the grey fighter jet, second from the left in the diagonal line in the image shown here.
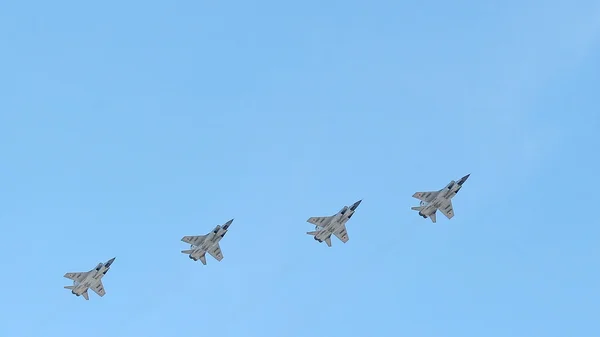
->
[181,219,233,265]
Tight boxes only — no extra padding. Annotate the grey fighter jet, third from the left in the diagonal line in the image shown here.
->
[306,200,362,247]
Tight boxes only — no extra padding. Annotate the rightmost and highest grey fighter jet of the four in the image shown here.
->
[411,174,471,223]
